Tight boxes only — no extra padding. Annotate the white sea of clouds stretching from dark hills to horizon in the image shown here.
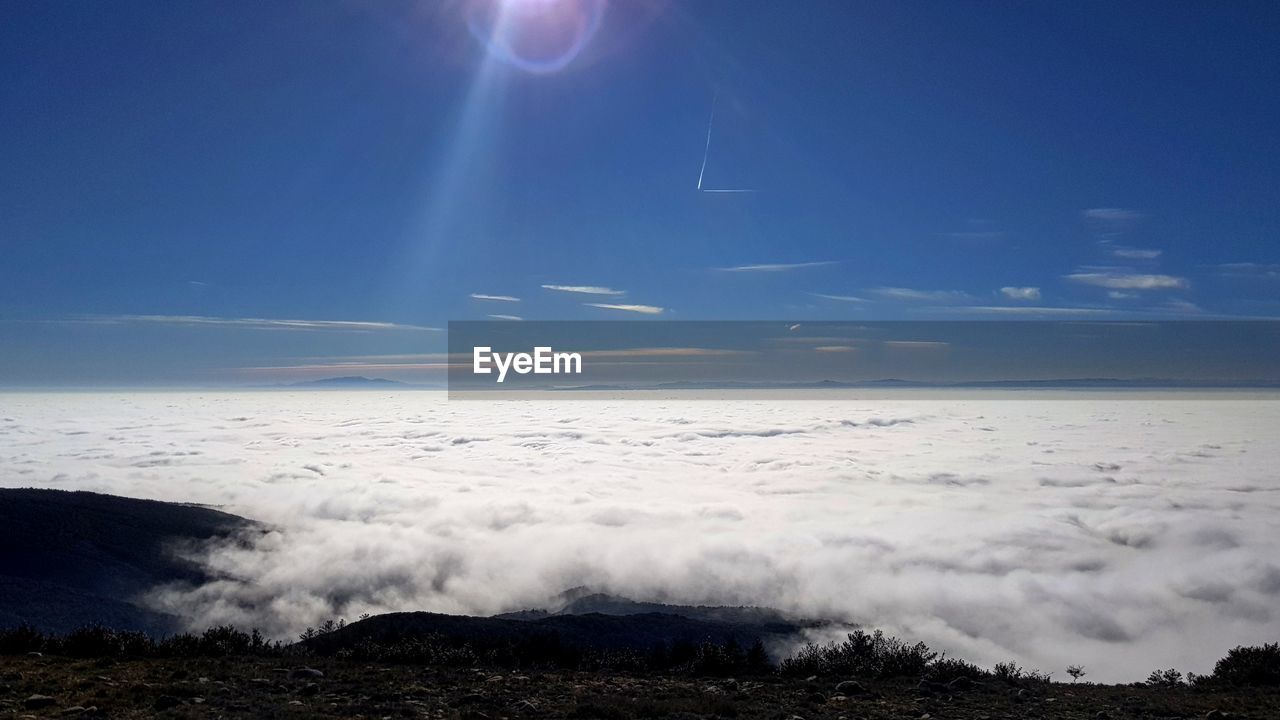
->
[0,391,1280,680]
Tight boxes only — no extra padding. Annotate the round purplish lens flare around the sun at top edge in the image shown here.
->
[467,0,608,74]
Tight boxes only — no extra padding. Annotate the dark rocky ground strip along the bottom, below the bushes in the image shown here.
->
[0,656,1280,720]
